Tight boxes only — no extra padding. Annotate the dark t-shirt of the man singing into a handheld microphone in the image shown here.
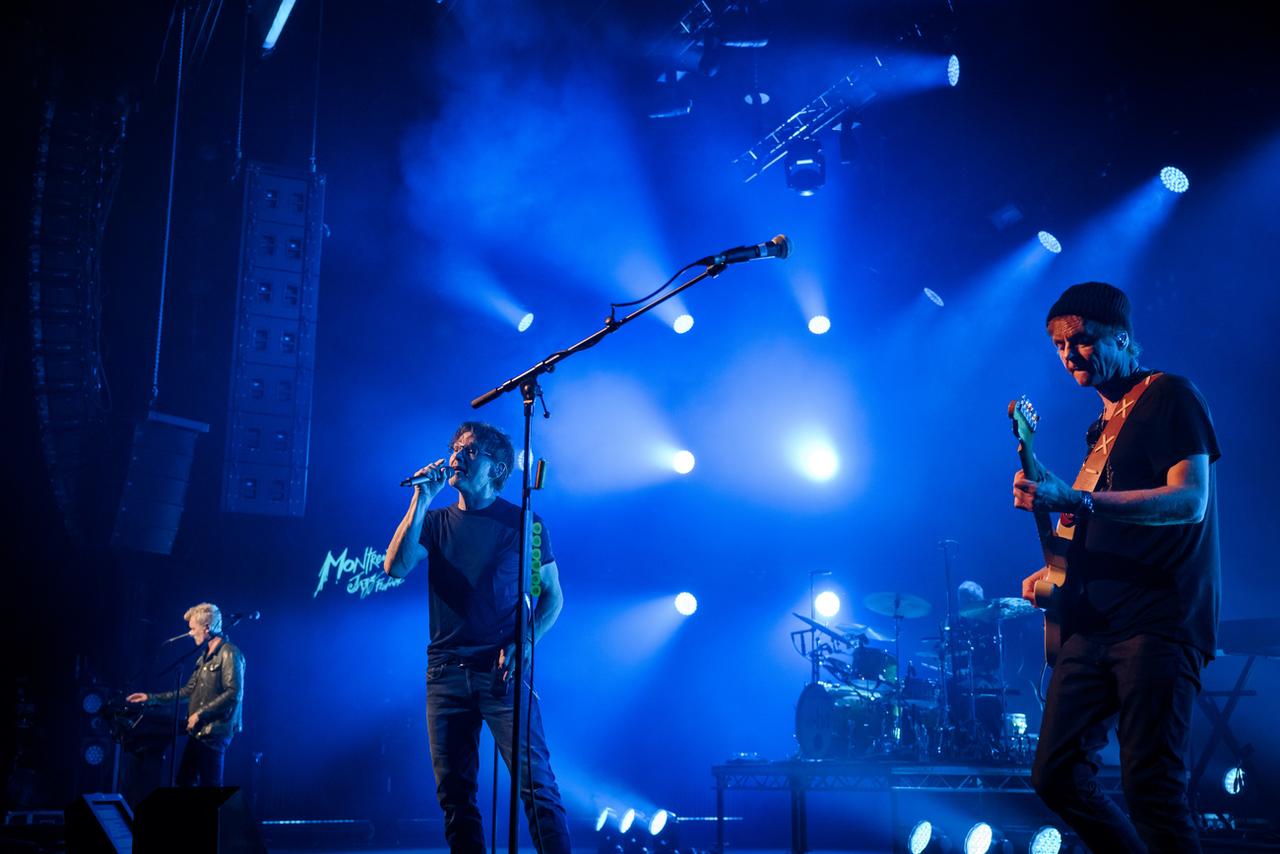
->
[419,498,556,667]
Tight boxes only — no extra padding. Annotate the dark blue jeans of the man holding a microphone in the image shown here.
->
[426,663,570,854]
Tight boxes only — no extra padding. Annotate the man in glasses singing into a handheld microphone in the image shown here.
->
[383,421,570,854]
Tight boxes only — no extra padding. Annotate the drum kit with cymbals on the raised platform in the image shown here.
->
[791,593,1036,763]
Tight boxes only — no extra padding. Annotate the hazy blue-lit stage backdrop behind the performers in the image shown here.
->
[0,0,1280,845]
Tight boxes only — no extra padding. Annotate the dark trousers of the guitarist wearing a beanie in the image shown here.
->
[1032,635,1201,854]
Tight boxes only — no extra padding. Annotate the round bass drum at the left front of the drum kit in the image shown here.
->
[796,682,883,759]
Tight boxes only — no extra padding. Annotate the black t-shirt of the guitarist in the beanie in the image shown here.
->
[1062,374,1220,661]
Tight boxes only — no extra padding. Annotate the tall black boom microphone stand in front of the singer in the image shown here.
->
[471,264,726,854]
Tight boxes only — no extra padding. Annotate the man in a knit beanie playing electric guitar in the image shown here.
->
[1014,282,1220,853]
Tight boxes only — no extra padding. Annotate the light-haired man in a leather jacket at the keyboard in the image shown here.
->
[125,602,244,786]
